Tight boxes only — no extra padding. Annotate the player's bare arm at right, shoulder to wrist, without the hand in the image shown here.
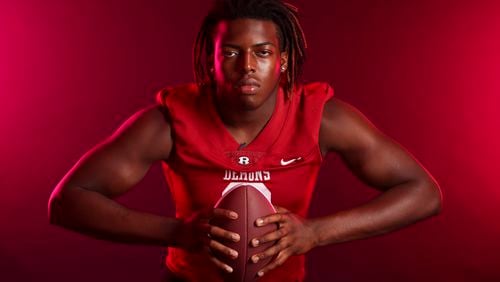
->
[311,98,441,245]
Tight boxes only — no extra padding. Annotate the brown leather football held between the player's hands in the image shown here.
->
[211,184,278,281]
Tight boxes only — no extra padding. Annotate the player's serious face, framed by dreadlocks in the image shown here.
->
[213,19,287,110]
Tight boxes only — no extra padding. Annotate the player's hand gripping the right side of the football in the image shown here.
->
[251,206,317,276]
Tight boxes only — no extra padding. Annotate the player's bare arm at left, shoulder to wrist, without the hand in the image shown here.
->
[49,107,179,245]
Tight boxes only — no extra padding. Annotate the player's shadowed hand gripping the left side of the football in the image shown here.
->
[173,208,240,273]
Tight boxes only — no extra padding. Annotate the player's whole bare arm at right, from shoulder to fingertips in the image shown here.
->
[242,98,441,276]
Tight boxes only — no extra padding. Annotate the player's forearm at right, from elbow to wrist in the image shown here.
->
[311,181,441,246]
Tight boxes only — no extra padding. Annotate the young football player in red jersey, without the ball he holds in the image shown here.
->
[49,0,441,281]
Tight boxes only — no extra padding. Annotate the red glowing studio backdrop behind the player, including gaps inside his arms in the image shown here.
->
[0,0,500,281]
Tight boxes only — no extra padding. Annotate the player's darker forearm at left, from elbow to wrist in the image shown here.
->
[49,187,180,246]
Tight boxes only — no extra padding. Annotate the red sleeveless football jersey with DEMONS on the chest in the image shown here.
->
[157,83,333,281]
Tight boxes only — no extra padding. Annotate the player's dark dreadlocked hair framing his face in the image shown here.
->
[193,0,307,97]
